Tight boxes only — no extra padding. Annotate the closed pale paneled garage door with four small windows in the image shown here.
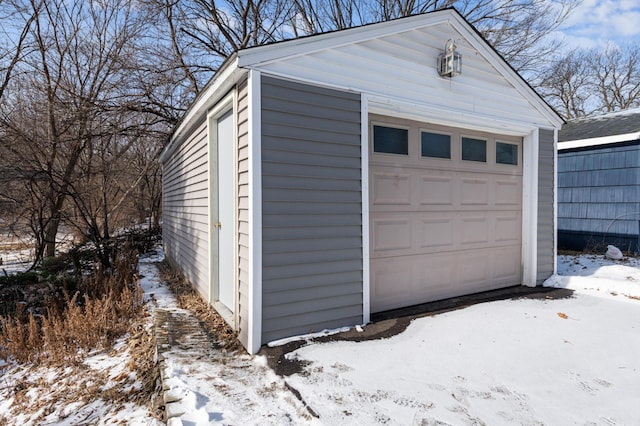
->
[369,116,522,312]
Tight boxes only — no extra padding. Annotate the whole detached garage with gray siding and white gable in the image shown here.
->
[161,9,562,353]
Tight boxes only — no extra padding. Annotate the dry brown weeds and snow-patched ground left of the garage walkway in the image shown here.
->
[0,243,162,426]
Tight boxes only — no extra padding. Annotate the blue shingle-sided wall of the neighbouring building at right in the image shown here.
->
[558,145,640,236]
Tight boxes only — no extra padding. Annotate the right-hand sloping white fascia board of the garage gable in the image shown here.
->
[451,14,564,129]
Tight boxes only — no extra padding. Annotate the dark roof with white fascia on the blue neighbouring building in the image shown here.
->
[558,108,640,149]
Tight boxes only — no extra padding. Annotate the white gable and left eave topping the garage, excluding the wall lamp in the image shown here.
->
[165,8,564,160]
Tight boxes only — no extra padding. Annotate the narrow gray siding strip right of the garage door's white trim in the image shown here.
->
[536,129,555,284]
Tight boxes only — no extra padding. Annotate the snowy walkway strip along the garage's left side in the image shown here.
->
[140,251,311,425]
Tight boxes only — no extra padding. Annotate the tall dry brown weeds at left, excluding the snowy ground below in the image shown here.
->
[0,249,143,366]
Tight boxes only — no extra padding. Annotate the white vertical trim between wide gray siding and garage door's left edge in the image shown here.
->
[360,94,371,324]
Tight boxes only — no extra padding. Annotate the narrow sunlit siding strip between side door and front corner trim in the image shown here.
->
[237,81,250,347]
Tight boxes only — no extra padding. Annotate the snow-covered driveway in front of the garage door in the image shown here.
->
[280,256,640,425]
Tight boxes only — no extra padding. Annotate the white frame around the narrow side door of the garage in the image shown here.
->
[207,90,239,330]
